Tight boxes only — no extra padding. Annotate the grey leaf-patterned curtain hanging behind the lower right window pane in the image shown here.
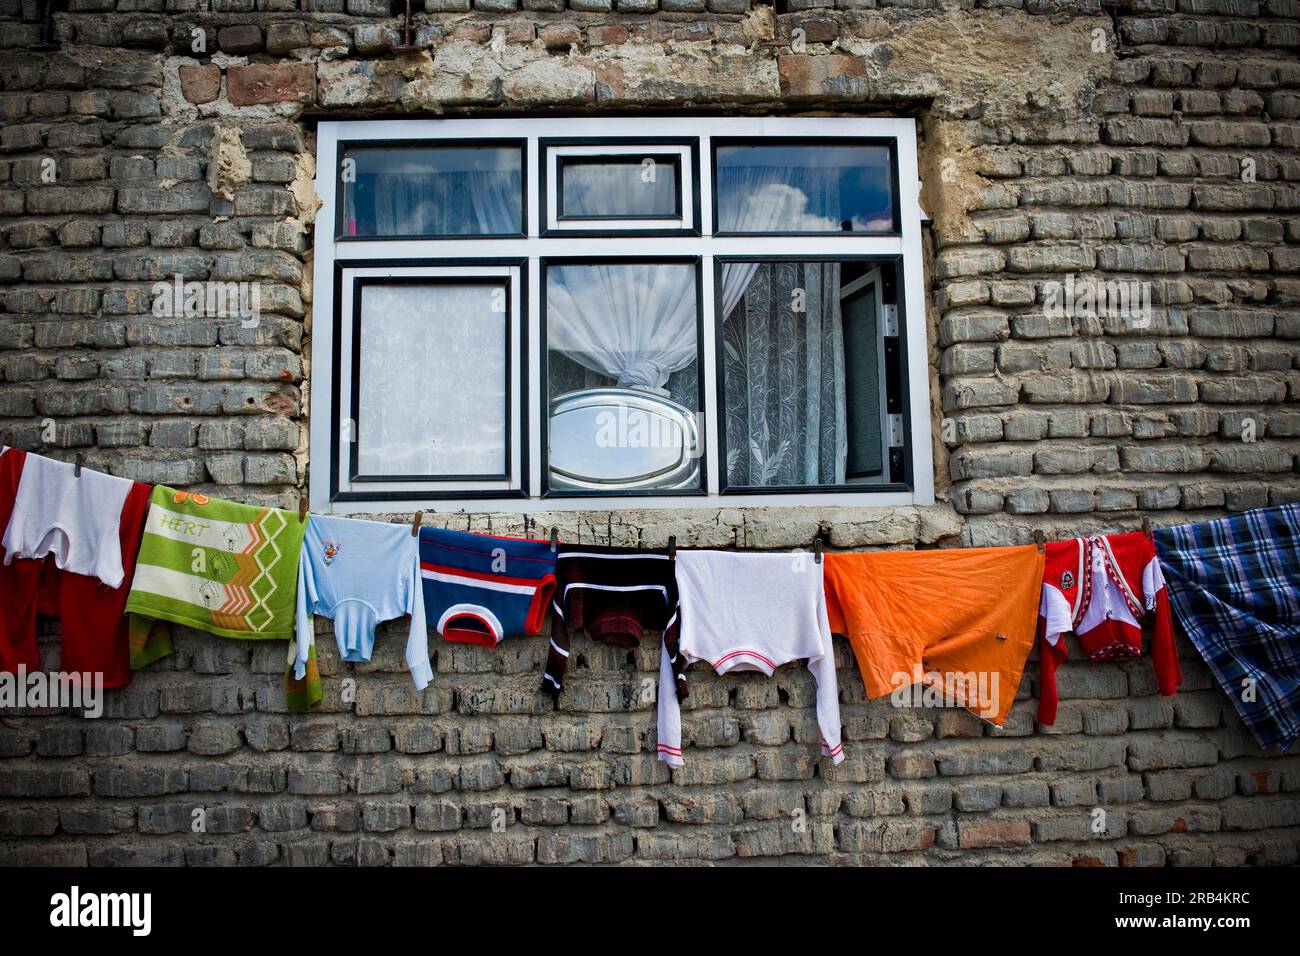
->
[723,263,848,486]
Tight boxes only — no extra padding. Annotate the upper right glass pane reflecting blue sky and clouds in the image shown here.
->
[718,146,894,233]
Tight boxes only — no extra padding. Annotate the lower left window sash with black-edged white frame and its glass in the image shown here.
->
[330,260,525,501]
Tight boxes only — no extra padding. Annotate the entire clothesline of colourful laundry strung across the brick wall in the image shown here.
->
[0,447,1300,766]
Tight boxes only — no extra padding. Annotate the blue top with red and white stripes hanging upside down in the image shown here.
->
[420,528,555,648]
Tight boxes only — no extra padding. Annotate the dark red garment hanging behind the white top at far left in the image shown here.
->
[0,449,151,687]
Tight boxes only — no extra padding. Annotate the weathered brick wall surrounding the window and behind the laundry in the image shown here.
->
[0,0,1300,865]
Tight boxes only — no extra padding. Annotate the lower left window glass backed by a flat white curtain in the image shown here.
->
[356,282,508,476]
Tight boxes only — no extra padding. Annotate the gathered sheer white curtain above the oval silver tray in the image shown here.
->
[546,263,697,394]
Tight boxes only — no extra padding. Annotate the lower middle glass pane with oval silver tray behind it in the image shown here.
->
[546,263,702,493]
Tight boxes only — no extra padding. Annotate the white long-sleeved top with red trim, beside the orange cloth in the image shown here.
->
[658,551,844,767]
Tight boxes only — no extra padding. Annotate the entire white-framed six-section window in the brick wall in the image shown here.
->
[311,117,933,512]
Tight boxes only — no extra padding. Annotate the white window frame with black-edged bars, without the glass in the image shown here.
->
[309,116,935,514]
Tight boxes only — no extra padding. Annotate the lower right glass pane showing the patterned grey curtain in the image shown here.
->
[720,260,884,488]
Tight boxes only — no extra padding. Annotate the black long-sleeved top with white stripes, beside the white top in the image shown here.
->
[542,545,686,698]
